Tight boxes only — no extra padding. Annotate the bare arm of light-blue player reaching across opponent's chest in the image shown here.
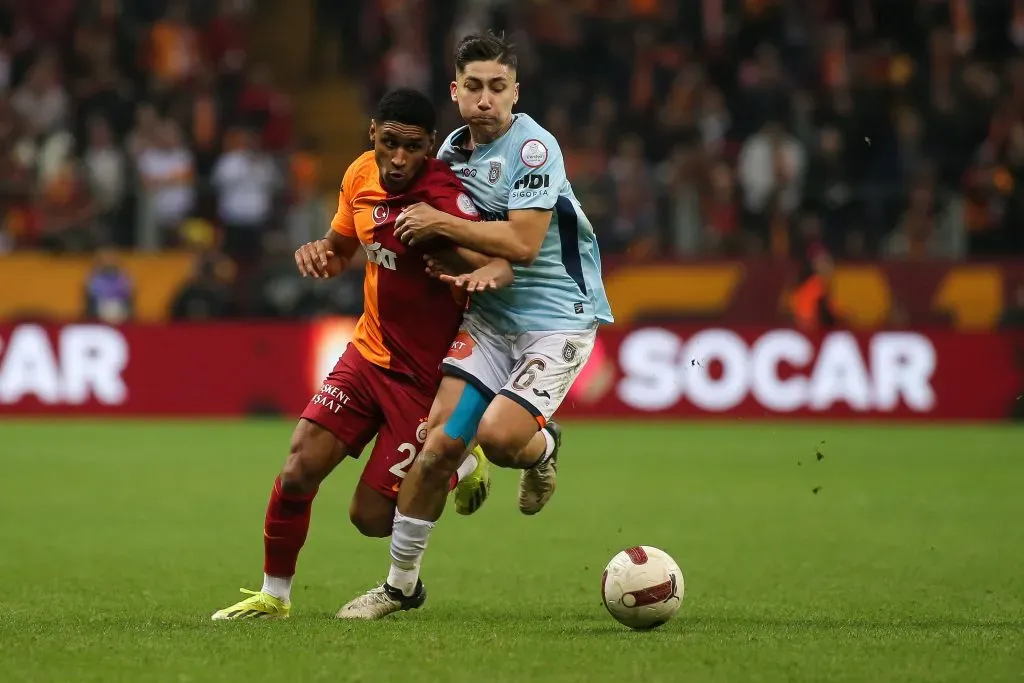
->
[394,204,552,265]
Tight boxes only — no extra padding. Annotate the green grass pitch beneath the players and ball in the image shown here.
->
[0,421,1024,683]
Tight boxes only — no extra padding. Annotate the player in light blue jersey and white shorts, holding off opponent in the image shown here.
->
[338,34,612,618]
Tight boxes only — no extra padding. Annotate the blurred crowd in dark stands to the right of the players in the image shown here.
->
[353,0,1024,259]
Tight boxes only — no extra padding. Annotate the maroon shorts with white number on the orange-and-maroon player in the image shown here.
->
[302,344,436,499]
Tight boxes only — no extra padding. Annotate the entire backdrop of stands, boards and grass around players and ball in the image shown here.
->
[0,0,1024,683]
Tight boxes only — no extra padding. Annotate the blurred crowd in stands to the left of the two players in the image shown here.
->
[0,0,359,319]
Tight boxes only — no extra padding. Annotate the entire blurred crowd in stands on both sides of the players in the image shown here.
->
[6,0,1024,325]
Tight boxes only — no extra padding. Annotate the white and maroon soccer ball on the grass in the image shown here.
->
[601,546,683,631]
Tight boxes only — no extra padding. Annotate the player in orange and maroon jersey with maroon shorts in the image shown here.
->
[213,89,512,620]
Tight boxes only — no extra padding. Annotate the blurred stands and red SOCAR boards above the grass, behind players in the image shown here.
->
[0,0,1024,420]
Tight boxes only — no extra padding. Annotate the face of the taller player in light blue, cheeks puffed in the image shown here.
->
[452,61,519,138]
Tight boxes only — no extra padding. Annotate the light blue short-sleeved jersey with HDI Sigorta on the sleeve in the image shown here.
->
[437,114,613,334]
